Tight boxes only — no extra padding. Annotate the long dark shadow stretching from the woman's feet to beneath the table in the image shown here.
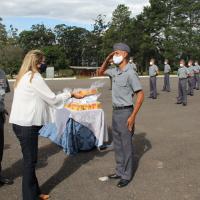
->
[41,149,109,194]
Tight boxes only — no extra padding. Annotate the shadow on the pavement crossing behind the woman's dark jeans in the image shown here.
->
[2,143,62,179]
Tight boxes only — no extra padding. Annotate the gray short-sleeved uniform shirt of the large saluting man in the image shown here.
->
[105,64,142,107]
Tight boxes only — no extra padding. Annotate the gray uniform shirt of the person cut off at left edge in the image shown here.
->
[0,69,10,112]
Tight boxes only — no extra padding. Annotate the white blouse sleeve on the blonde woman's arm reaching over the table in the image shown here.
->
[31,74,71,108]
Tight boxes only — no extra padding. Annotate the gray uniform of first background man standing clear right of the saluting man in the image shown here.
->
[149,65,158,99]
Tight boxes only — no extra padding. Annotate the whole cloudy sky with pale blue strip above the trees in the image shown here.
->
[0,0,149,31]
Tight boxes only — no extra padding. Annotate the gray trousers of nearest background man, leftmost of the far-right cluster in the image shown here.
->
[177,78,188,104]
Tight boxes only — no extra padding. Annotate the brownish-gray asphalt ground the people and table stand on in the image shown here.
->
[0,78,200,200]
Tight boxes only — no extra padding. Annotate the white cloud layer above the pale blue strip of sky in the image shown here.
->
[0,0,149,24]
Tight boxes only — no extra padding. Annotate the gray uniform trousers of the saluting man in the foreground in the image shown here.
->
[112,108,134,180]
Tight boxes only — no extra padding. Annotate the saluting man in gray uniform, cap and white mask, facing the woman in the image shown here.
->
[97,43,144,187]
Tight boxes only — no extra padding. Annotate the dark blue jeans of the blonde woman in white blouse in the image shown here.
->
[13,124,41,200]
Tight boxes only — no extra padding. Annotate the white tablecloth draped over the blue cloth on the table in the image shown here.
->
[54,108,108,147]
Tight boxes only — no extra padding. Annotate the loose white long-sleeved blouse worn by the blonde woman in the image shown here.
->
[9,72,71,126]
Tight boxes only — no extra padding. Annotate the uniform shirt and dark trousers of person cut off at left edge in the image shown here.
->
[0,69,10,175]
